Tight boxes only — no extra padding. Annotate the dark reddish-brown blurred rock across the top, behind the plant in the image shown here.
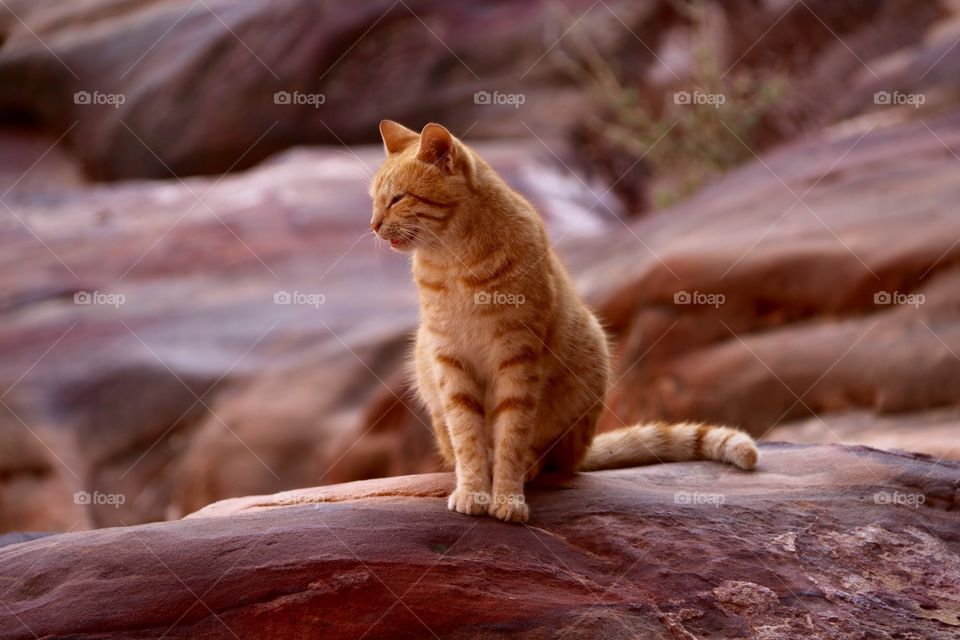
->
[0,0,948,180]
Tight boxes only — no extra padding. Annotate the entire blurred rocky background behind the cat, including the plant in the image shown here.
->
[0,0,960,540]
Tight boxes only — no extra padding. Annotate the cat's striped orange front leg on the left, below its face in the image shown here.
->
[434,350,491,515]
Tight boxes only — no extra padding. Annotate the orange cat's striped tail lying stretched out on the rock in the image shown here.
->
[579,422,760,471]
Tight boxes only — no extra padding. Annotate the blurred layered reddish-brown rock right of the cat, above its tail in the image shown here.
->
[588,112,960,455]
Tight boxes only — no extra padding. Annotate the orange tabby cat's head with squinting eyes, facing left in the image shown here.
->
[370,120,473,251]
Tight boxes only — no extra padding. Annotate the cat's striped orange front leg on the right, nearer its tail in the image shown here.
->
[488,349,542,522]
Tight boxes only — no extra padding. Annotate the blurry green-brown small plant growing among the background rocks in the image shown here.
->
[566,0,787,208]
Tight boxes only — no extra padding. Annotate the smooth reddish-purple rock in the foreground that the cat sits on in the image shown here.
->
[0,444,960,640]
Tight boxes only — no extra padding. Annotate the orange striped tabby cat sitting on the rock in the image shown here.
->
[370,120,758,522]
